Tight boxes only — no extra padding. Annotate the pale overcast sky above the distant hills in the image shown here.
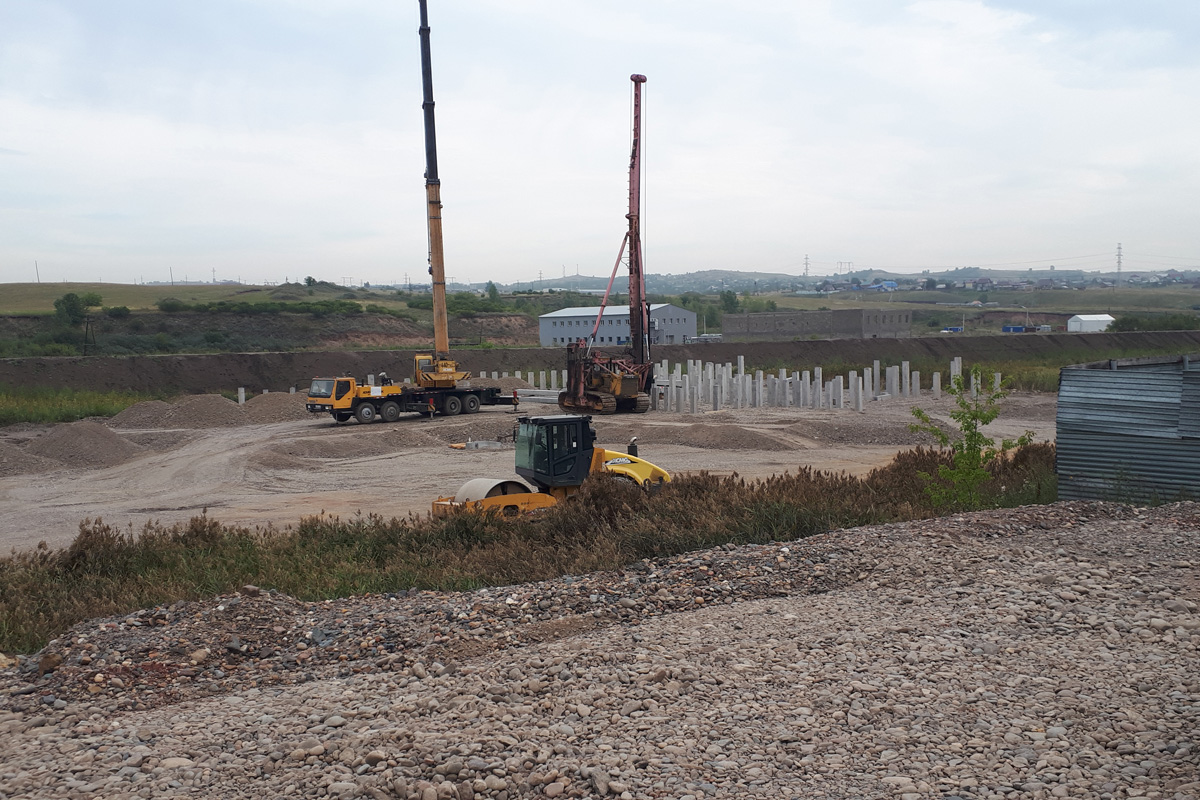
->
[0,0,1200,284]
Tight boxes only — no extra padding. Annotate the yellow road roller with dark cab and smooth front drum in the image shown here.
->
[433,414,671,515]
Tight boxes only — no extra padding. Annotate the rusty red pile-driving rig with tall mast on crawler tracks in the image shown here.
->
[558,74,654,414]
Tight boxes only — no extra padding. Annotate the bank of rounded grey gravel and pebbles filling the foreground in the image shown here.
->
[0,503,1200,800]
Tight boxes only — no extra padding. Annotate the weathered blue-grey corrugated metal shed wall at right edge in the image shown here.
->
[1056,360,1200,503]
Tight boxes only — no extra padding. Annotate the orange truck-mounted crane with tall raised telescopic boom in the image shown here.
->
[306,0,517,422]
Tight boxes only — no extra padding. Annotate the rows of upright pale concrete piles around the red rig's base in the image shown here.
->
[481,356,1001,414]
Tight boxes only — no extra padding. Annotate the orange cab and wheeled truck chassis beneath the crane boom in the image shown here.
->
[305,378,518,422]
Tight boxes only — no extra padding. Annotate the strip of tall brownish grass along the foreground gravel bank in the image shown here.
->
[0,445,1056,652]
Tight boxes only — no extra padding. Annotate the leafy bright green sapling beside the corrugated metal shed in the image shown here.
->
[908,365,1033,511]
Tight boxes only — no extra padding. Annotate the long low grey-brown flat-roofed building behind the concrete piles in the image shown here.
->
[721,308,912,341]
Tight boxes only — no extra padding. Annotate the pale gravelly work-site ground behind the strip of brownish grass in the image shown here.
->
[0,395,1056,552]
